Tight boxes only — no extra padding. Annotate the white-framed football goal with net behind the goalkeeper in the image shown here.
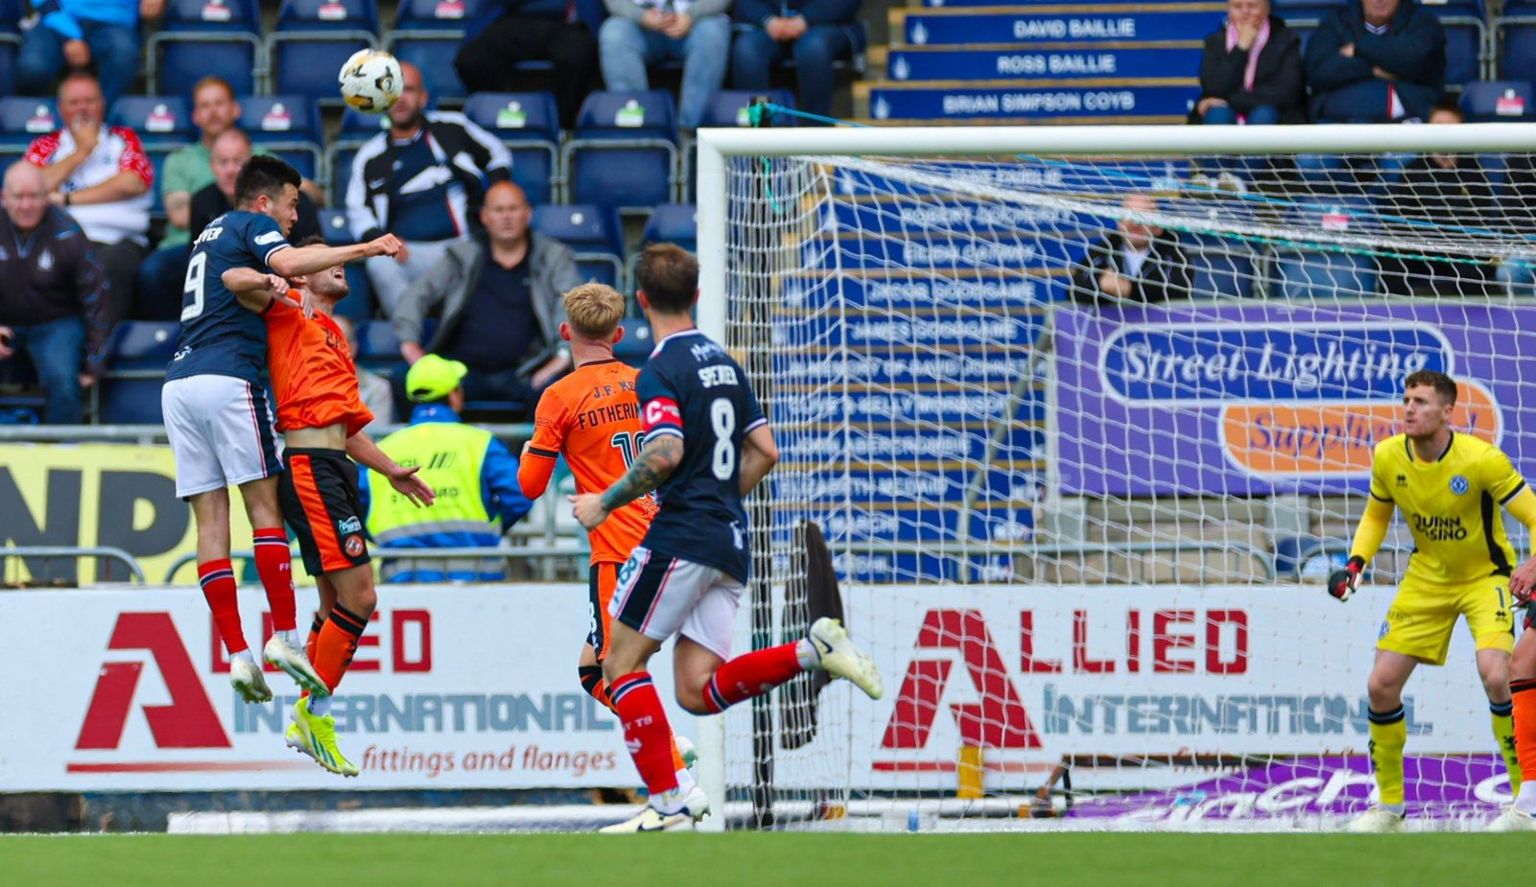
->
[699,125,1536,829]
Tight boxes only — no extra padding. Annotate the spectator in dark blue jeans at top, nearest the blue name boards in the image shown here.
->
[731,0,865,115]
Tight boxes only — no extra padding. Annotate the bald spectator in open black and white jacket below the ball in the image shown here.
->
[347,60,511,315]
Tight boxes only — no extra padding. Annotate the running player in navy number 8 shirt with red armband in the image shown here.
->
[573,244,882,832]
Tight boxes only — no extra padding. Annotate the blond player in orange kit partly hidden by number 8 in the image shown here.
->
[518,283,693,799]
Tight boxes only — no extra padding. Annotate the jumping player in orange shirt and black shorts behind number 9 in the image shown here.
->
[223,238,433,776]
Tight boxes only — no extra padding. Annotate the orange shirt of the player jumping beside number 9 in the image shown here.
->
[263,300,373,437]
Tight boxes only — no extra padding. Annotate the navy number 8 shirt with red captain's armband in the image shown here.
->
[636,329,768,583]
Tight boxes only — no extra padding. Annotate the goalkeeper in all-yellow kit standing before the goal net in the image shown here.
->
[1329,370,1536,832]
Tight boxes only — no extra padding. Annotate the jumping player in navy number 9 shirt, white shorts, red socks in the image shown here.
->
[160,157,399,703]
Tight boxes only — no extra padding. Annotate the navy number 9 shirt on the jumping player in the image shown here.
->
[166,209,289,384]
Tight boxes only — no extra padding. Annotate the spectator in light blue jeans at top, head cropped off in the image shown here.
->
[598,0,731,129]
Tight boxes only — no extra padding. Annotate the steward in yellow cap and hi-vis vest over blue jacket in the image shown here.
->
[361,354,533,583]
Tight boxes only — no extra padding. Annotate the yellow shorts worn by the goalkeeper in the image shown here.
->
[1376,575,1514,666]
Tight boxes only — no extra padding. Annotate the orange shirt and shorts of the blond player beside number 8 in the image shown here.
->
[518,360,656,564]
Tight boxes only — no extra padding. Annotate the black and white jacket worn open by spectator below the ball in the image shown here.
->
[347,111,511,241]
